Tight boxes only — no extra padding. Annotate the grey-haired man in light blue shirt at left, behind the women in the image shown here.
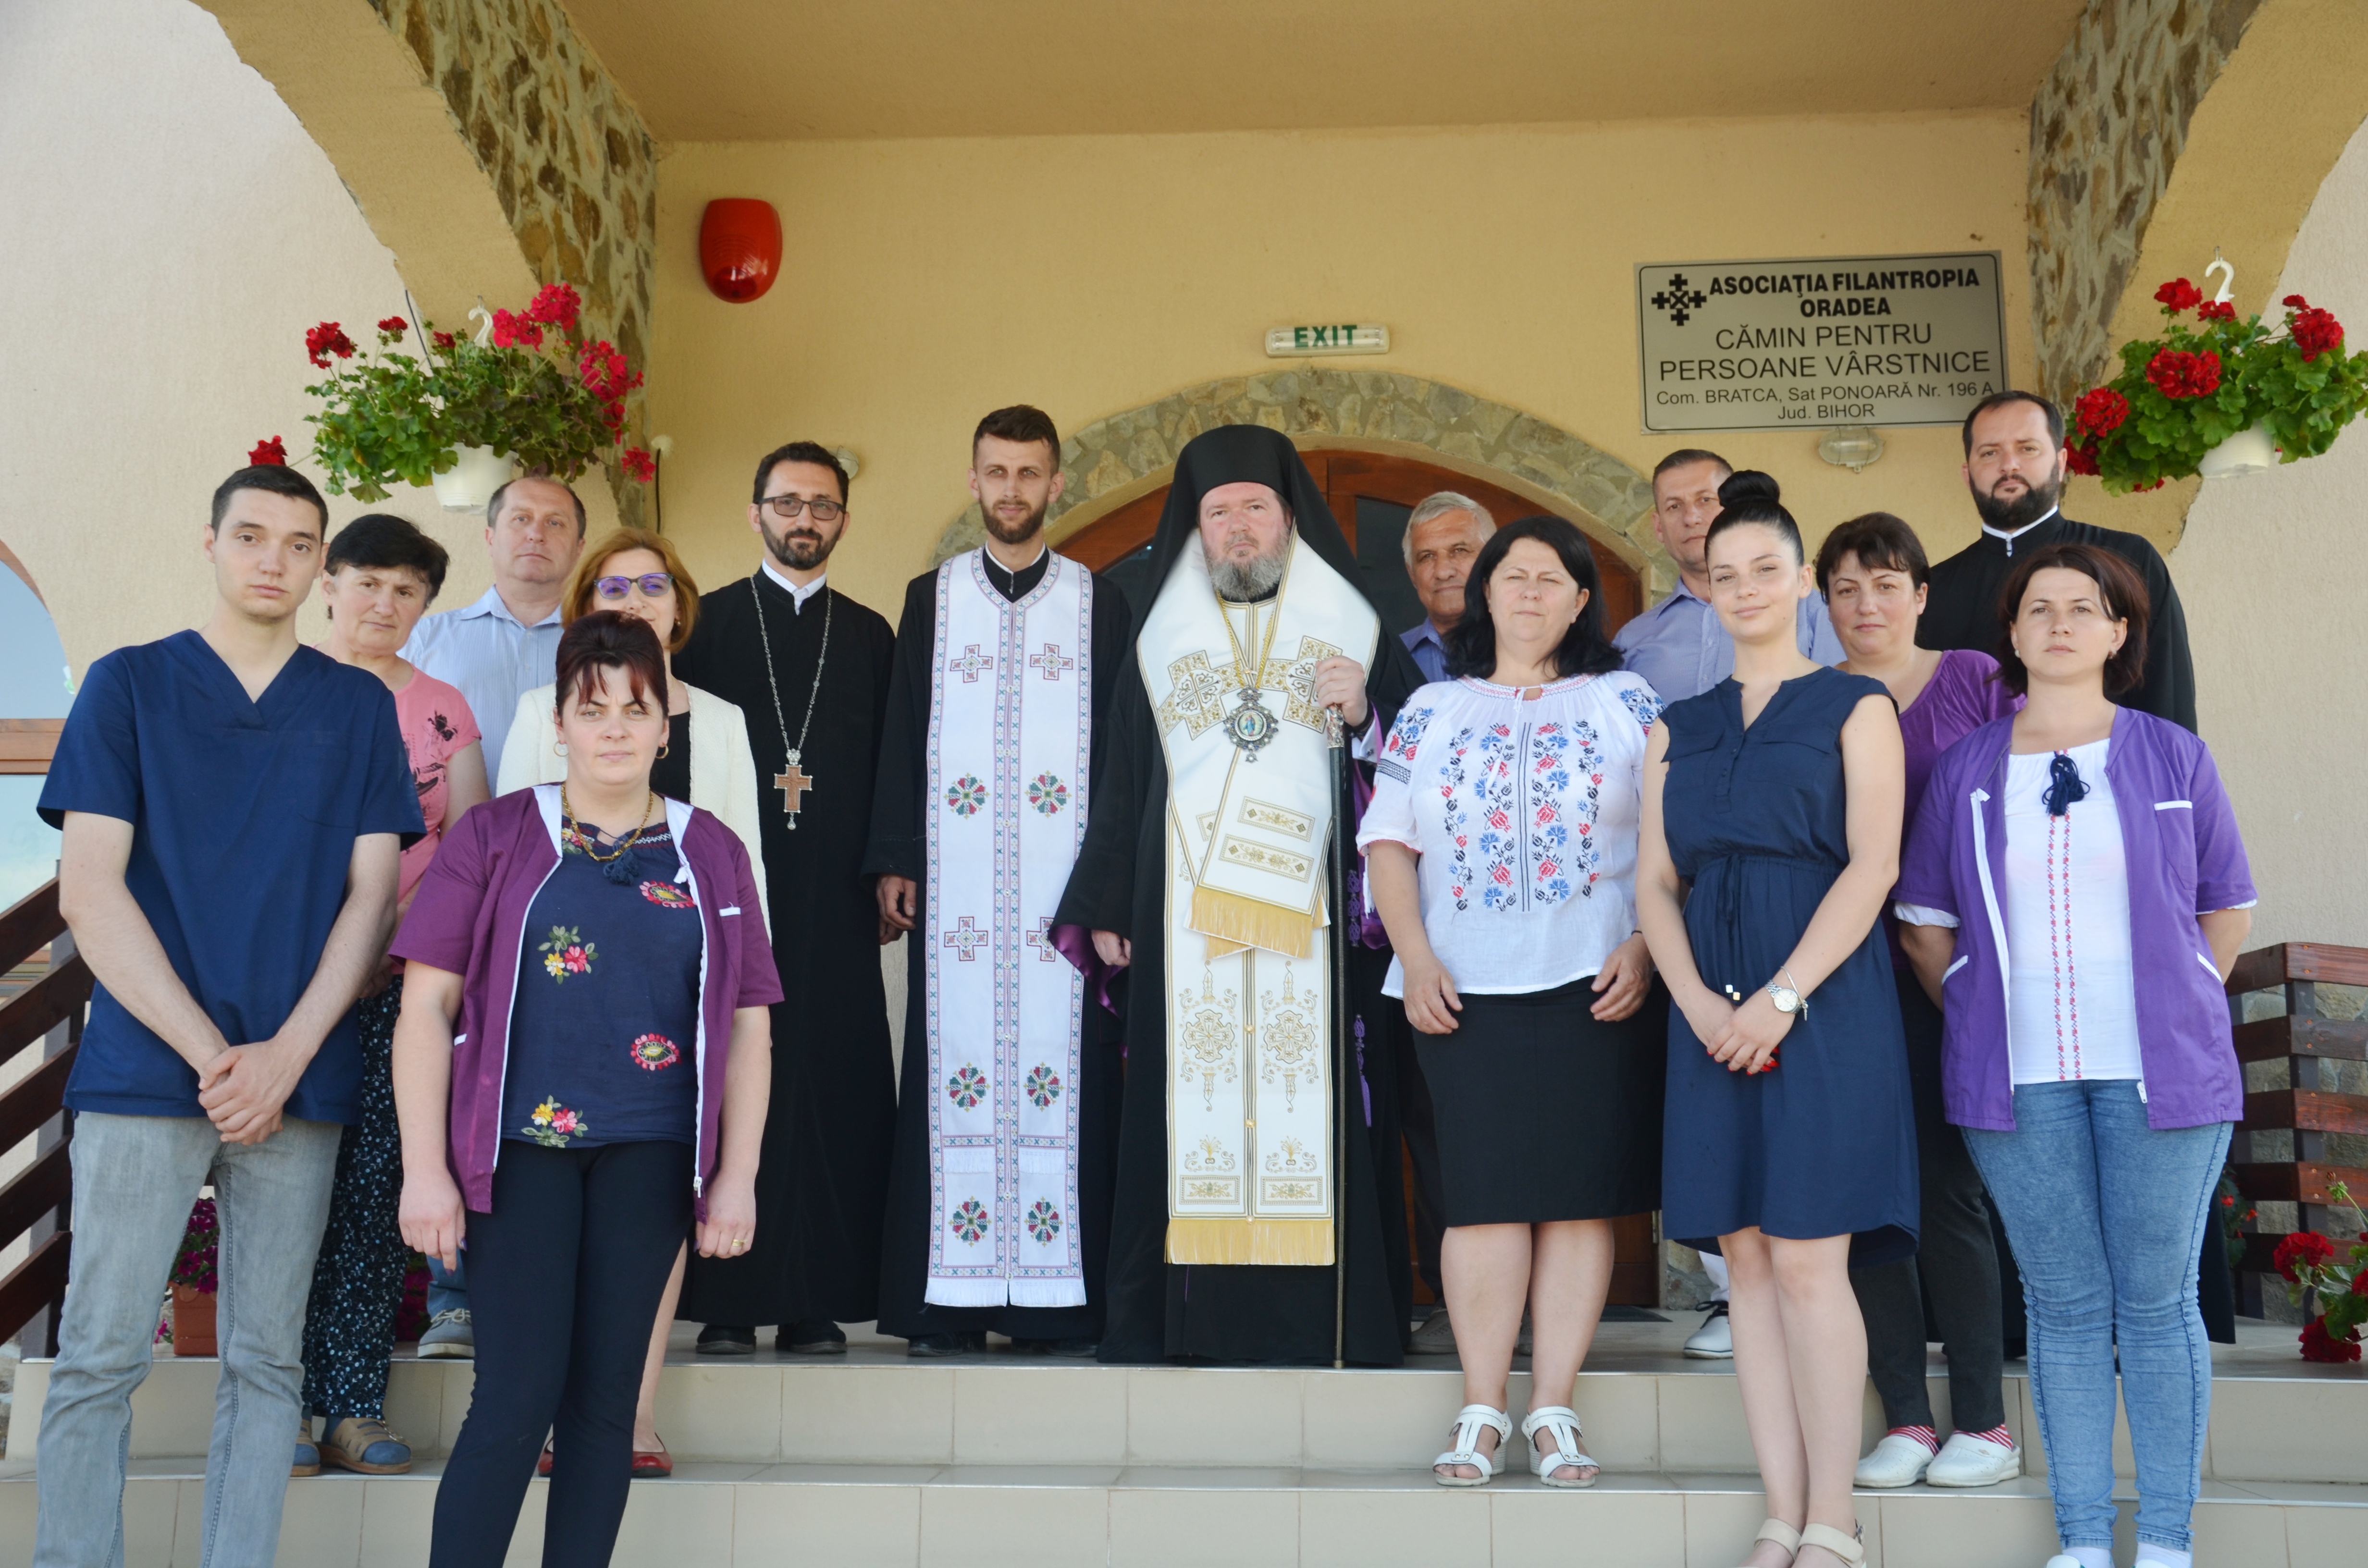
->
[403,478,585,779]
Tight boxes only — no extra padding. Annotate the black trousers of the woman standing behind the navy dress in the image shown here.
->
[1850,971,2006,1433]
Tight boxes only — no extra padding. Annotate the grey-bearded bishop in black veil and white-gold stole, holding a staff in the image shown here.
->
[1056,426,1421,1367]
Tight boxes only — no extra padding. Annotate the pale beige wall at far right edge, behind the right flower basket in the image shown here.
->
[2169,110,2368,947]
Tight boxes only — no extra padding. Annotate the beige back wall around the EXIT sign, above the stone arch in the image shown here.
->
[649,111,2032,613]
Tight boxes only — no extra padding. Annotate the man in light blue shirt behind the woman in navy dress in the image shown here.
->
[1613,448,1850,703]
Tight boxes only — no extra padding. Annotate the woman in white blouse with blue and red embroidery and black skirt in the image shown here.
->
[1357,516,1667,1487]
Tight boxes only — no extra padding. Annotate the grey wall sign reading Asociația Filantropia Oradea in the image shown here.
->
[1636,251,2008,431]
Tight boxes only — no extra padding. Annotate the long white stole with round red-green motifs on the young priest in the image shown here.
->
[919,550,1094,1308]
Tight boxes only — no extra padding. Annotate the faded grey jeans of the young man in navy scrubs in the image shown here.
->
[33,1113,344,1568]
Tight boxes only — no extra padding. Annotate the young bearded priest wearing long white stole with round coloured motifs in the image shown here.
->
[864,405,1132,1357]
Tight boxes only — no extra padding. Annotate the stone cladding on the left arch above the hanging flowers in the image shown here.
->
[370,0,658,524]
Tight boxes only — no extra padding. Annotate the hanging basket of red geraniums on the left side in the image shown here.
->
[303,284,654,507]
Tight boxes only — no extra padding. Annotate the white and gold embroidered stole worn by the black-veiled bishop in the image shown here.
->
[1136,538,1381,1265]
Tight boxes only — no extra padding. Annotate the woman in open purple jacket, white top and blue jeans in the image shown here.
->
[1897,545,2254,1568]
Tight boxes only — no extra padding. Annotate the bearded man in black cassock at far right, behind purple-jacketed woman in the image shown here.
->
[1909,391,2195,739]
